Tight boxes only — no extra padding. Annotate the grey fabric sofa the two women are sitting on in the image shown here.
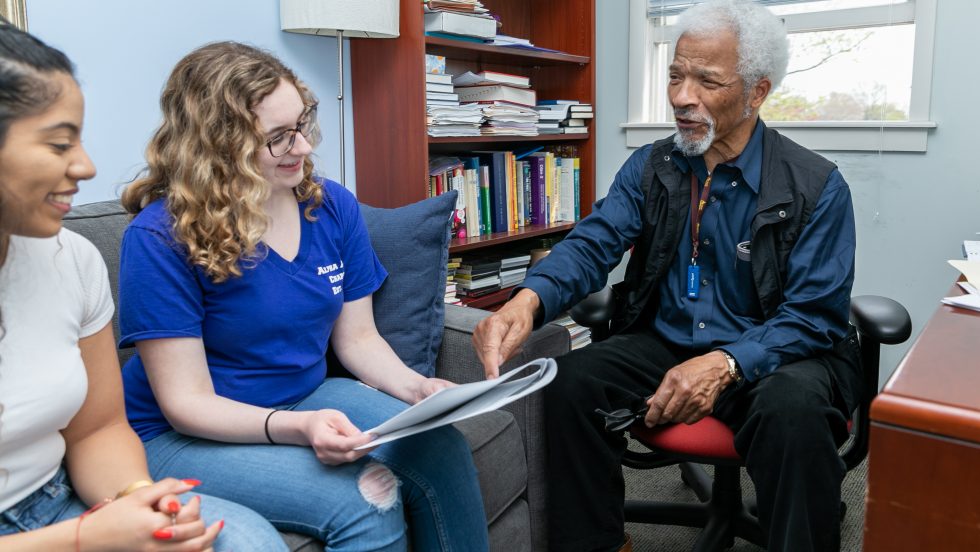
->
[65,201,569,552]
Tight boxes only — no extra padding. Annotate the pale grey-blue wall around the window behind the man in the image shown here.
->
[596,0,980,381]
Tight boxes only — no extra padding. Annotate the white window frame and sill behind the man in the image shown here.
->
[620,0,937,152]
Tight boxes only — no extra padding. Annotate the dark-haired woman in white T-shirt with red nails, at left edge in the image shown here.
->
[0,20,284,551]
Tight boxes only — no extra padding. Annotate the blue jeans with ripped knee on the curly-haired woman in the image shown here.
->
[145,378,489,552]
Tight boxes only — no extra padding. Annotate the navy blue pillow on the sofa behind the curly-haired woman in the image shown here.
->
[361,191,457,377]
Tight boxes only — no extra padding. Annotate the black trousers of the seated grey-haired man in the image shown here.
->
[543,330,861,552]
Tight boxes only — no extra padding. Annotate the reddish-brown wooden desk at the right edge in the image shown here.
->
[864,286,980,552]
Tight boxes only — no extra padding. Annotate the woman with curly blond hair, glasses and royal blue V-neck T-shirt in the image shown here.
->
[119,42,488,552]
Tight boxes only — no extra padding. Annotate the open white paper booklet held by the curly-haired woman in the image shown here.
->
[357,358,558,449]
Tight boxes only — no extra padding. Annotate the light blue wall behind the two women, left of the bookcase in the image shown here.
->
[27,0,354,203]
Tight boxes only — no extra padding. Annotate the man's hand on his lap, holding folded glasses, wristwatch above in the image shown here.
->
[643,351,735,427]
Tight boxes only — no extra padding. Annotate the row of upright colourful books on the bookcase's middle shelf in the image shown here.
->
[427,146,581,238]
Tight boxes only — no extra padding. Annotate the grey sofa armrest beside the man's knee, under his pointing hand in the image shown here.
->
[436,305,571,550]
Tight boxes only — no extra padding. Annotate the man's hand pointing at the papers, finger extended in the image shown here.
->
[473,288,541,379]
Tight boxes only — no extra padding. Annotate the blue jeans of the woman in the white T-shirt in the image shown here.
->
[0,468,287,552]
